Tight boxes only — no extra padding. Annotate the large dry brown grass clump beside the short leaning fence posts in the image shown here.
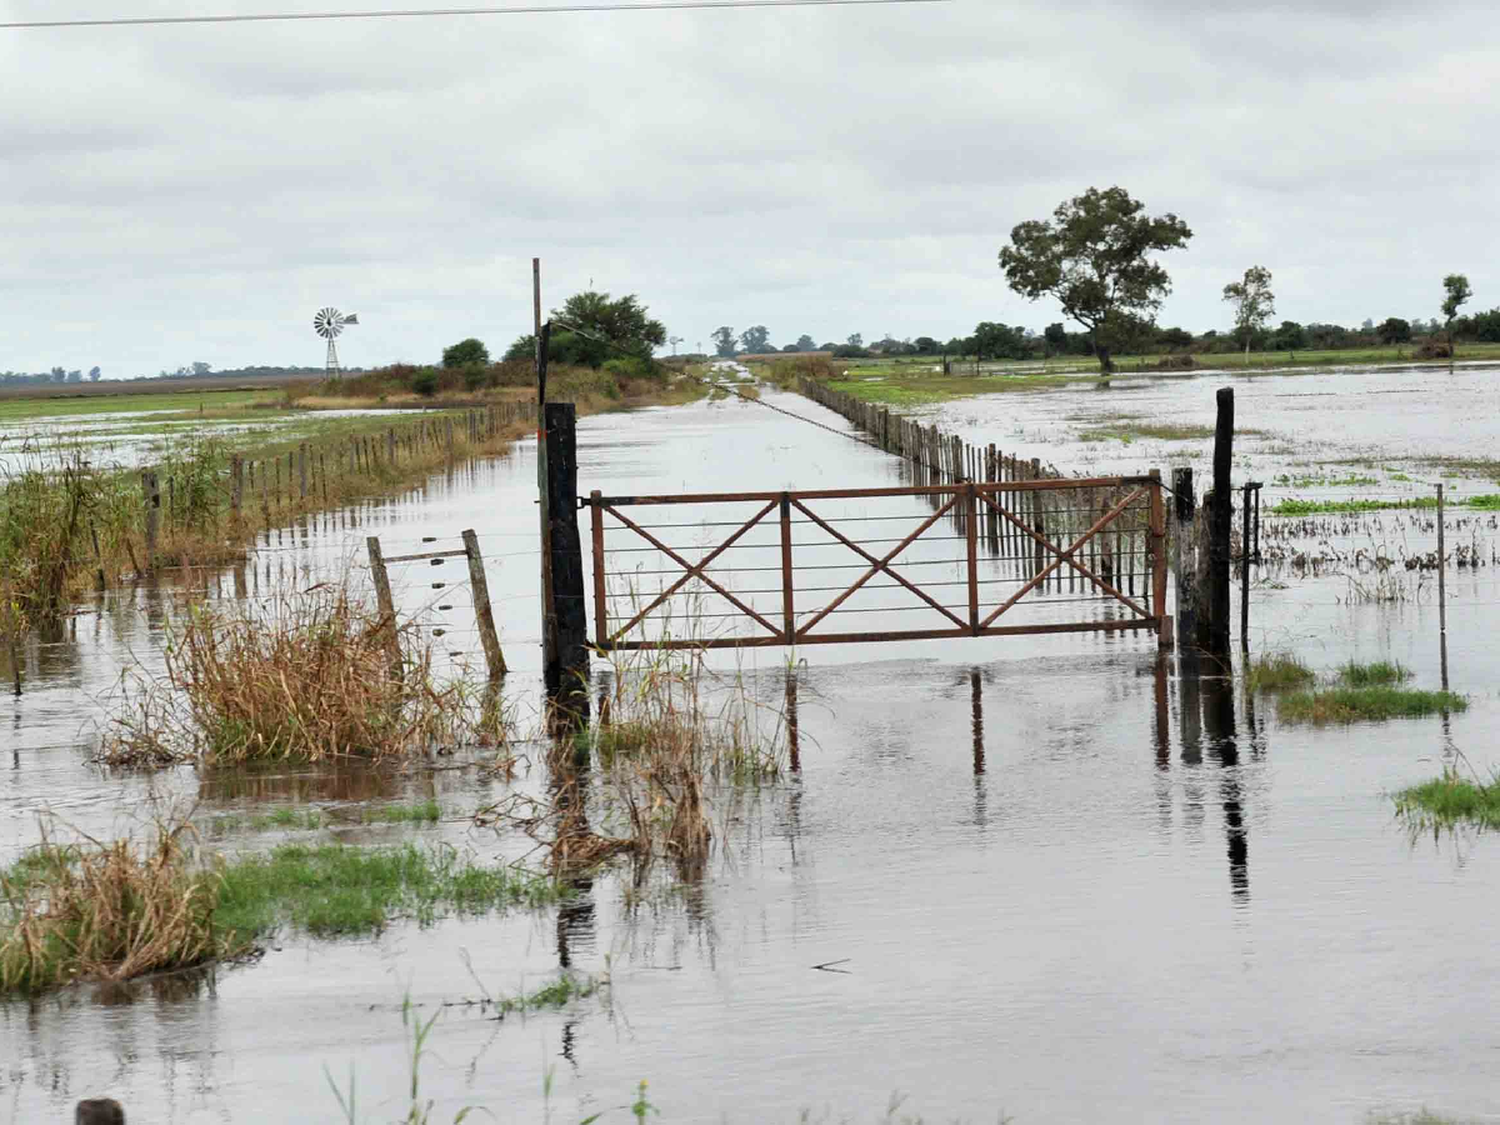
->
[104,587,504,765]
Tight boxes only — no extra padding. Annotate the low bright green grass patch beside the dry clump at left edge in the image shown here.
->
[215,843,561,941]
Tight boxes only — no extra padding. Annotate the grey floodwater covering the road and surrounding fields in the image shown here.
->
[0,374,1500,1124]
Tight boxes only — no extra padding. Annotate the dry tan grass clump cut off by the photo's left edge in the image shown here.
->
[0,825,237,995]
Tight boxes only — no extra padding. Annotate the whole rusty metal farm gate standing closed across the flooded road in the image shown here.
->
[582,473,1169,651]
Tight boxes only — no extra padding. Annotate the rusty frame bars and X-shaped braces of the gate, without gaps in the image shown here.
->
[582,473,1167,651]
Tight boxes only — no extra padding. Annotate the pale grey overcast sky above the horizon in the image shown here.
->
[0,0,1500,378]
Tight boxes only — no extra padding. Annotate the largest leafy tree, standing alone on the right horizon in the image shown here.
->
[1001,188,1193,372]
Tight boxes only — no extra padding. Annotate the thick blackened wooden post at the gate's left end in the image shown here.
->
[546,402,588,710]
